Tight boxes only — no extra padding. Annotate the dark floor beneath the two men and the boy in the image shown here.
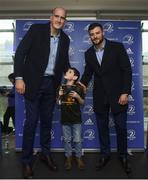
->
[0,134,148,179]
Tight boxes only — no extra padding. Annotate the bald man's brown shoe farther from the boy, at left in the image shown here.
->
[22,164,33,179]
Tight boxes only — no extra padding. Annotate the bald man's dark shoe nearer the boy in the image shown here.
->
[40,154,58,171]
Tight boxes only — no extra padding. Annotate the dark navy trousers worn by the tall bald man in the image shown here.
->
[22,76,55,164]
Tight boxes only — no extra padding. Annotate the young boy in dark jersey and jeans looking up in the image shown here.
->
[57,67,84,170]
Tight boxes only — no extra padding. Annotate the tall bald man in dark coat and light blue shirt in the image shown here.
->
[14,7,70,178]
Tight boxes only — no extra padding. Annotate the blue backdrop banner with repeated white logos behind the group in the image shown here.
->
[15,20,144,150]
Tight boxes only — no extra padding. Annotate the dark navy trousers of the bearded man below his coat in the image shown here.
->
[96,106,127,158]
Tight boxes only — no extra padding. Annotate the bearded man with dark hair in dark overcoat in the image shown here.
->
[80,23,132,172]
